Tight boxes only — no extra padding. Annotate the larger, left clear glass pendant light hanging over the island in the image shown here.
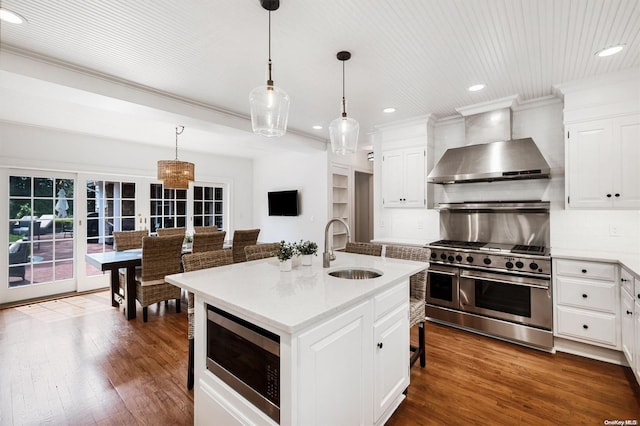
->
[249,0,289,138]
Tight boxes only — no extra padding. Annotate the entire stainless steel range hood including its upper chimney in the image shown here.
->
[427,108,550,184]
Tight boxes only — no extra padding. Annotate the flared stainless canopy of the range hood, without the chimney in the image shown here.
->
[427,138,550,184]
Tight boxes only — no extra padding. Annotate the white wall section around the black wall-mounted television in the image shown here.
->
[253,150,328,245]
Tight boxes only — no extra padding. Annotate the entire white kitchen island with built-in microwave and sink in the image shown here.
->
[166,252,428,425]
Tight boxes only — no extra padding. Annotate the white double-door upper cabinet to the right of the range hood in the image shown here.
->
[566,114,640,209]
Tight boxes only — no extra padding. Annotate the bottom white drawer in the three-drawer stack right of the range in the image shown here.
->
[556,306,619,348]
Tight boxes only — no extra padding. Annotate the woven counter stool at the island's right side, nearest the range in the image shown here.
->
[385,246,429,367]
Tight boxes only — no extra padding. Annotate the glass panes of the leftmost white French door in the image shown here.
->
[8,176,74,287]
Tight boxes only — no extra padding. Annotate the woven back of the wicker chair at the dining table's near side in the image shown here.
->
[141,235,184,281]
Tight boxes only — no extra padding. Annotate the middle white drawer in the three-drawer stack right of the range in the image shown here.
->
[556,277,618,314]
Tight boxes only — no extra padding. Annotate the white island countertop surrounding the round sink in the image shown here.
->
[166,252,428,333]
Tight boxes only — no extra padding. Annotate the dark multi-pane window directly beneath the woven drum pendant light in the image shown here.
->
[150,183,187,232]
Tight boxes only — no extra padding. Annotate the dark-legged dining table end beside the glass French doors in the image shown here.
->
[85,249,142,320]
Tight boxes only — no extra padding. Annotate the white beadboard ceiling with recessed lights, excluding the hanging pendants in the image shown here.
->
[0,0,640,158]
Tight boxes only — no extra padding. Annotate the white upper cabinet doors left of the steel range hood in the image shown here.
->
[382,148,426,207]
